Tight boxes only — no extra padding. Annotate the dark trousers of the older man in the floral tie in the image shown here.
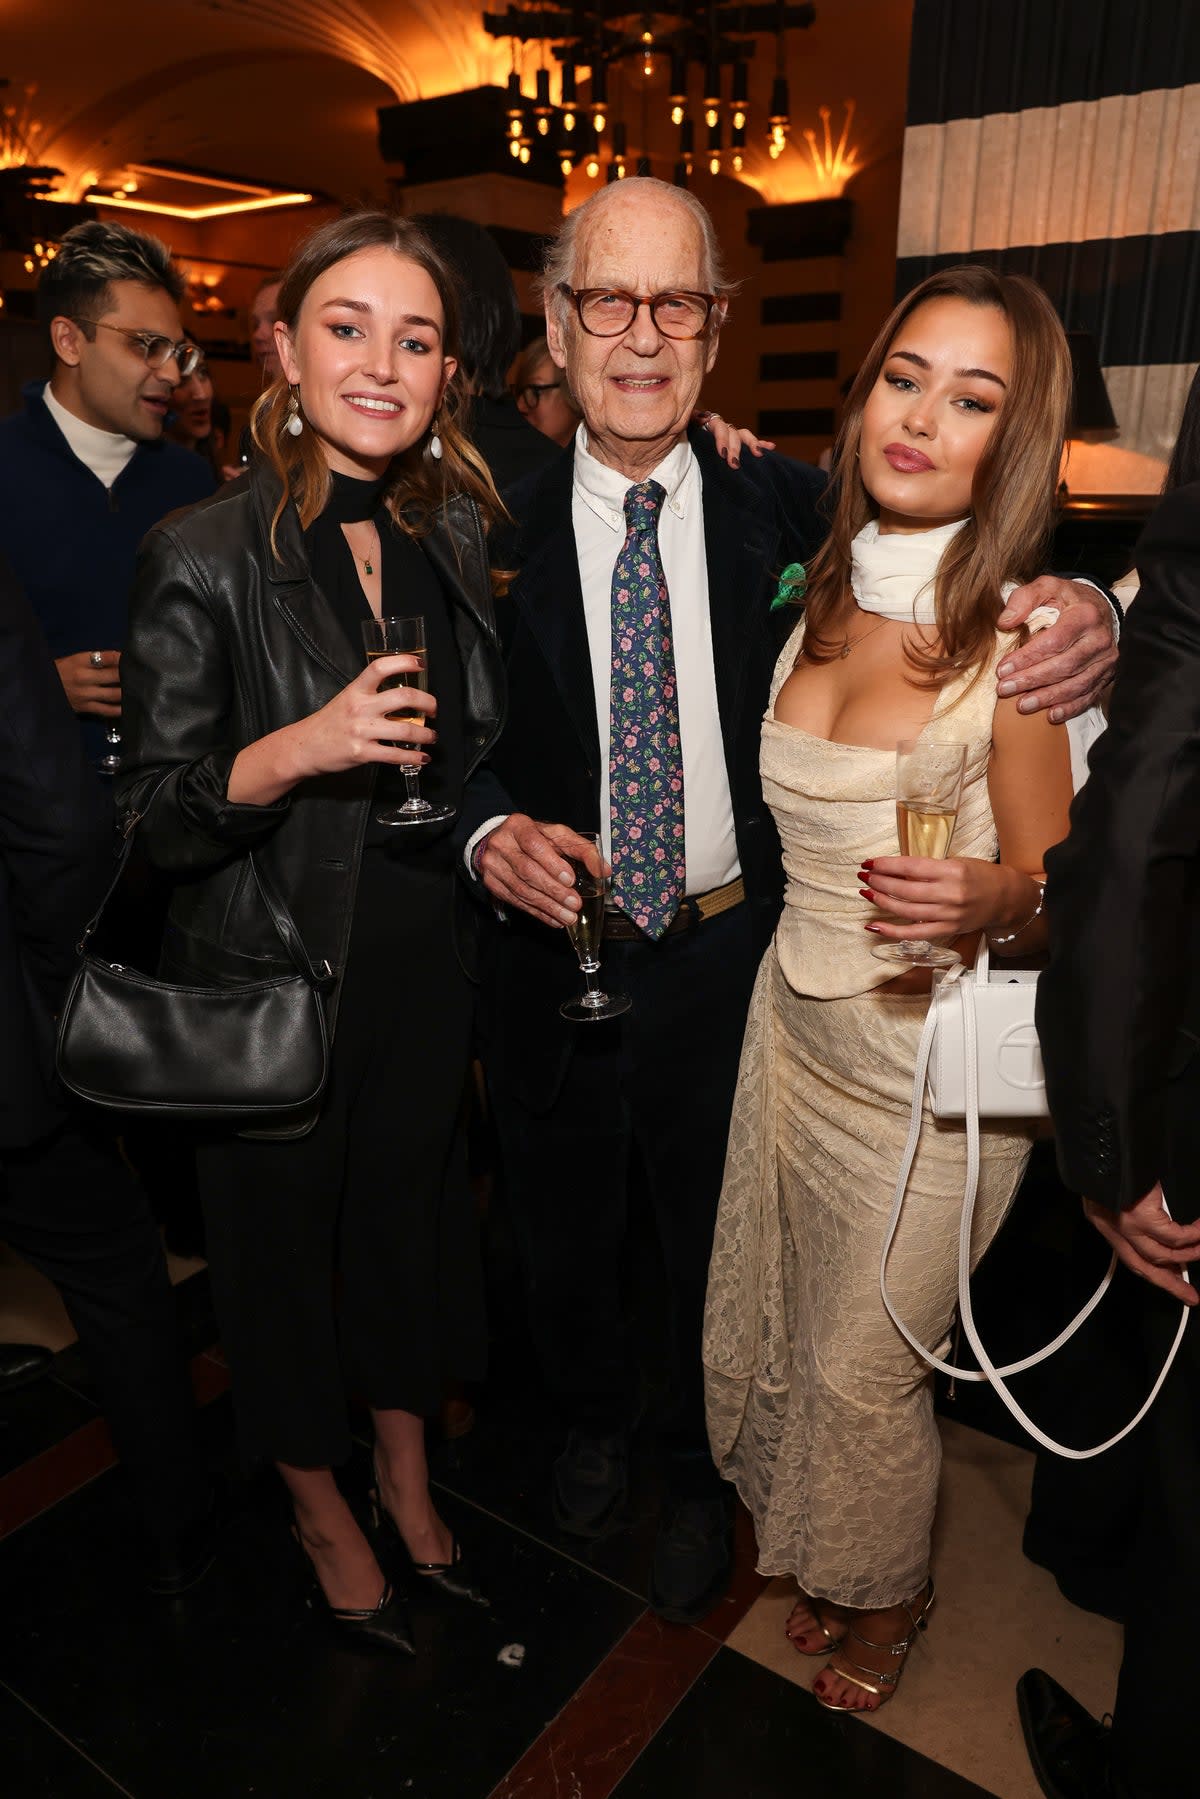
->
[489,905,757,1497]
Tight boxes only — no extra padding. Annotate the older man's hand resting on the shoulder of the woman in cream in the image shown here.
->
[997,574,1117,725]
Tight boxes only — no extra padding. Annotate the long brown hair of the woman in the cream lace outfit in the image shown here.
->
[804,263,1070,685]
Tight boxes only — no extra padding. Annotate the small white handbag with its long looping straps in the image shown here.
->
[880,939,1191,1461]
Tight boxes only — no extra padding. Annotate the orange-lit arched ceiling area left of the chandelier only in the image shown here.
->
[0,0,506,198]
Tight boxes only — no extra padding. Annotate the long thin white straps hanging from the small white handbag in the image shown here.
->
[880,968,1191,1461]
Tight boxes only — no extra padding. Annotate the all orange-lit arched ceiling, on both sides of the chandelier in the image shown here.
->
[0,0,912,200]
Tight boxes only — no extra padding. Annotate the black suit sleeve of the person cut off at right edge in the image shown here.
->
[1038,486,1200,1207]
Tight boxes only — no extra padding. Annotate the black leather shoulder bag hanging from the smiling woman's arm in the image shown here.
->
[56,795,335,1119]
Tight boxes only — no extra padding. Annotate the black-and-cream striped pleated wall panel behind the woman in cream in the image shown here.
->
[896,0,1200,459]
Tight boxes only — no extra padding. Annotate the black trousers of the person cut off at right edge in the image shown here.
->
[1112,1061,1200,1799]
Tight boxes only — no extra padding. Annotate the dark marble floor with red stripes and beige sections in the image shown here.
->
[0,1223,1119,1799]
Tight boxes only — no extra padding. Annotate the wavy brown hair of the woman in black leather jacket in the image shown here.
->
[250,209,504,549]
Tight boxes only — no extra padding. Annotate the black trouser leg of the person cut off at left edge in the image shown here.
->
[0,1119,210,1545]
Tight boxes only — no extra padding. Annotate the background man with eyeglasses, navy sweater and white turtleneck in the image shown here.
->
[0,219,214,766]
